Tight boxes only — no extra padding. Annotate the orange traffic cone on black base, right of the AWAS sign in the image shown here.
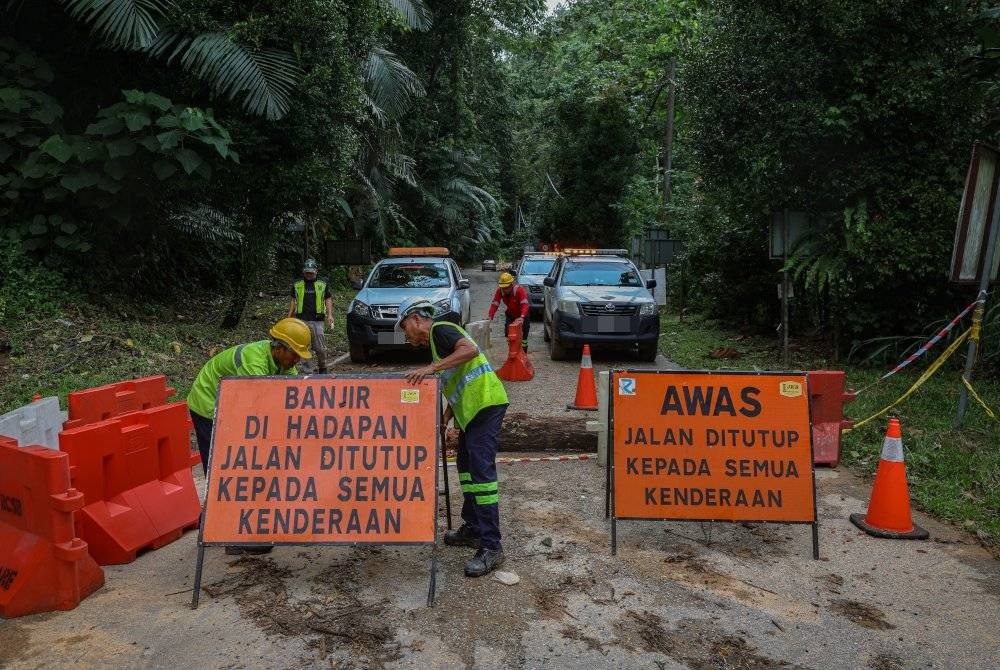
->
[851,418,930,540]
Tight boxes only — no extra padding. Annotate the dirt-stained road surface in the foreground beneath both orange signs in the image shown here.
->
[0,461,1000,670]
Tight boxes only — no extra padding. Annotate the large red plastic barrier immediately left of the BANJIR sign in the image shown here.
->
[59,402,201,565]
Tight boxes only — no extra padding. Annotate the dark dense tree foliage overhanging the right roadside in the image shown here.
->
[682,0,983,336]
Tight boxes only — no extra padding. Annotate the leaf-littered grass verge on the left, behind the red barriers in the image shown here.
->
[0,289,354,413]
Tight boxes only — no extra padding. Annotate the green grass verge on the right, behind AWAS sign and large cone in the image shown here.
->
[660,314,1000,548]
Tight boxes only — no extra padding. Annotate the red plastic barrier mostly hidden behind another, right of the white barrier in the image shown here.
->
[63,375,176,430]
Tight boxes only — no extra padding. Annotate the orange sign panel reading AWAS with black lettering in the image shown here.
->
[611,371,816,523]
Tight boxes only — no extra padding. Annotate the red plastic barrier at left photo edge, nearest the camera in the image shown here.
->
[0,440,104,618]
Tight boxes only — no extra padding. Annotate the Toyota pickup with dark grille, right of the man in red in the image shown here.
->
[542,249,660,361]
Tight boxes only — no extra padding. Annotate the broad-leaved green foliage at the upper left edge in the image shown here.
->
[0,40,238,262]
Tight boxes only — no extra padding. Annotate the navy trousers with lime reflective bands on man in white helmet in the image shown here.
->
[457,405,507,550]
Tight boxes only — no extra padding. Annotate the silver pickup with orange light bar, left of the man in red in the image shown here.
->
[347,247,472,363]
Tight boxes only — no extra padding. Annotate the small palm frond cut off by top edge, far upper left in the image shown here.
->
[60,0,174,49]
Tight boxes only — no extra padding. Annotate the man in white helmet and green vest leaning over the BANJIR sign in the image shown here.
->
[396,298,508,577]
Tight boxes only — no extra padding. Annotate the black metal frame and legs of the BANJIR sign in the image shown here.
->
[191,373,451,609]
